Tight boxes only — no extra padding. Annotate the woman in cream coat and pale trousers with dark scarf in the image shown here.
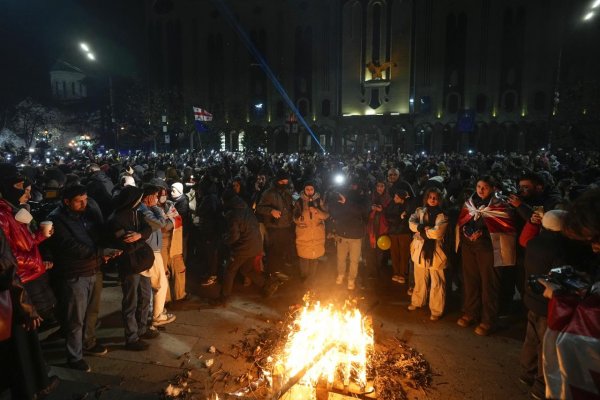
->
[408,187,448,321]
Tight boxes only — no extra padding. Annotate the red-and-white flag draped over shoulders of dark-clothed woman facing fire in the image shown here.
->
[458,194,516,233]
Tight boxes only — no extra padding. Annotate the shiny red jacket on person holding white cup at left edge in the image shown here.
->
[0,199,46,283]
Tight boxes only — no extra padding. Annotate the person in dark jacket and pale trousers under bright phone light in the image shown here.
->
[329,179,368,290]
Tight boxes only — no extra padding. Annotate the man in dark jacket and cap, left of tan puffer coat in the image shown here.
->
[256,170,295,273]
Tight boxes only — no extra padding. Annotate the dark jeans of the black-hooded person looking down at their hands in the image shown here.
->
[121,274,152,343]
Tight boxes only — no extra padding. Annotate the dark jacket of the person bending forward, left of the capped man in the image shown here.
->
[224,196,262,258]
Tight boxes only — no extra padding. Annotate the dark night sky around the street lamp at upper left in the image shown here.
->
[0,0,145,109]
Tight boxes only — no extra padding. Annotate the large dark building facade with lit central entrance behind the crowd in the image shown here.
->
[146,0,600,152]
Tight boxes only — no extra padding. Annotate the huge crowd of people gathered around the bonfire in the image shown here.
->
[0,149,600,398]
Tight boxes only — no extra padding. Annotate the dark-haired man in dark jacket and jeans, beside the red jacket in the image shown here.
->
[49,185,120,372]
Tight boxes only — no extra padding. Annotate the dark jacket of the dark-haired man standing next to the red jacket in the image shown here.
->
[48,202,104,279]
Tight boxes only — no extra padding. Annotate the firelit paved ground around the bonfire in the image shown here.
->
[0,256,528,400]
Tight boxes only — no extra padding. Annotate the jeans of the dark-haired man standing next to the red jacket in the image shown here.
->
[63,274,96,362]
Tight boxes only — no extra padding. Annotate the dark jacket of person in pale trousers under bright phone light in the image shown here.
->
[329,190,368,239]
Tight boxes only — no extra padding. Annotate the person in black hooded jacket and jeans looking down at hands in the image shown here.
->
[108,186,158,351]
